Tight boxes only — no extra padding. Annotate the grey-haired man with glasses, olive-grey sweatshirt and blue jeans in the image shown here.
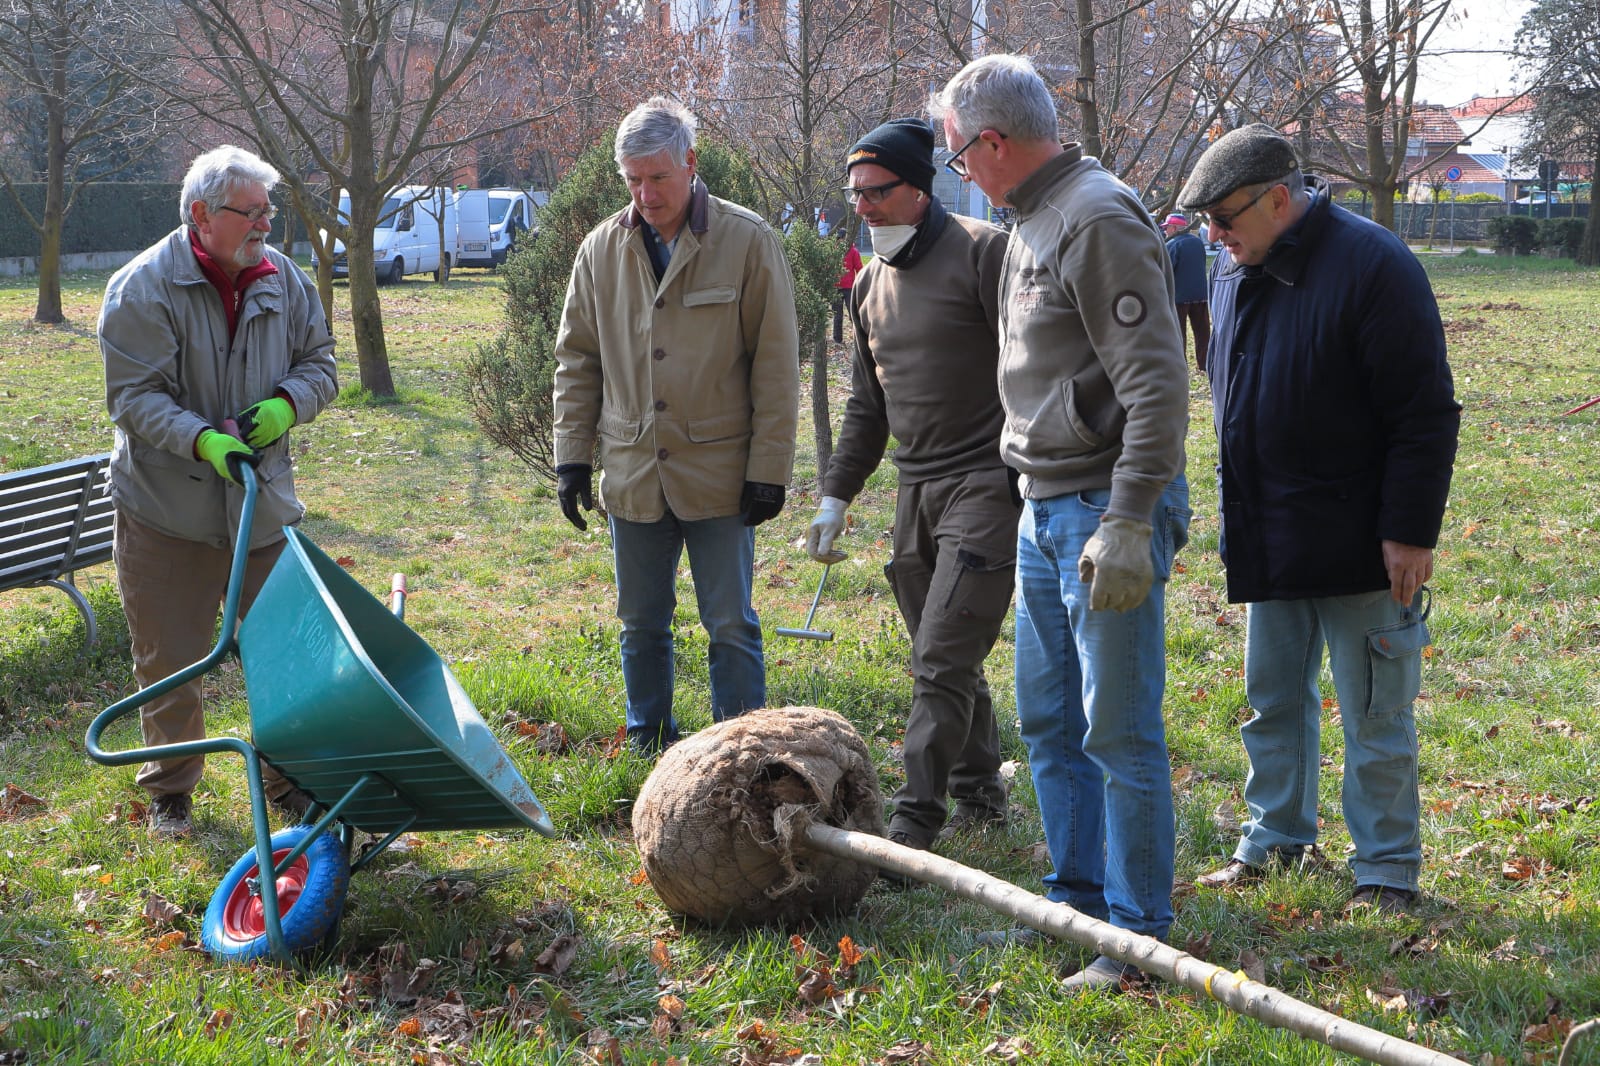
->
[934,54,1189,991]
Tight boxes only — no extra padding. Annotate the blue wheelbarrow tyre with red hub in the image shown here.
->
[200,826,350,962]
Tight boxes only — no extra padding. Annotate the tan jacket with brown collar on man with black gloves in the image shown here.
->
[555,178,800,522]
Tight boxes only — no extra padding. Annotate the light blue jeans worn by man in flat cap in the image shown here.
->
[1234,589,1422,892]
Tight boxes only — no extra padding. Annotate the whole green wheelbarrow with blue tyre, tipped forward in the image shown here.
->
[85,463,555,962]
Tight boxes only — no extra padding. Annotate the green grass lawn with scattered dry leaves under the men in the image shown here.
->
[0,256,1600,1066]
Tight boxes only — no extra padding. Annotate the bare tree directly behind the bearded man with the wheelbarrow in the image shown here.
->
[137,0,549,395]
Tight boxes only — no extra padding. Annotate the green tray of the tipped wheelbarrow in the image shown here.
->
[238,528,554,836]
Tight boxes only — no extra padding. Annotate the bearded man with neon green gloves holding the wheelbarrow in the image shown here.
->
[99,146,338,836]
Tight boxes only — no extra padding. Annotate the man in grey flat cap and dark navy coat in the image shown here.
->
[1178,123,1461,912]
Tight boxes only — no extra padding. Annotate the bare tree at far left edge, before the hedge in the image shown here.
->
[0,0,170,323]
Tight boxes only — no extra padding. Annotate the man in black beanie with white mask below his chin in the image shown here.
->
[806,118,1019,850]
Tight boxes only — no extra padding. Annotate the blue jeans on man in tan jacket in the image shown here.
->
[611,512,766,751]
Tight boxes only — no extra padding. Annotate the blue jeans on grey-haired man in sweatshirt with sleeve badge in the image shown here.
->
[1016,475,1189,936]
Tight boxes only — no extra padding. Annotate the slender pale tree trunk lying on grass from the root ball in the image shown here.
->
[806,825,1461,1066]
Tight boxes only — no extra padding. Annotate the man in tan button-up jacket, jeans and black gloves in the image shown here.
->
[555,96,800,752]
